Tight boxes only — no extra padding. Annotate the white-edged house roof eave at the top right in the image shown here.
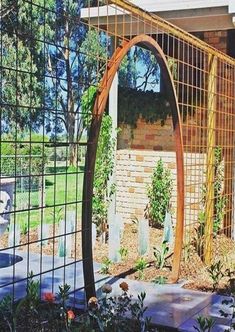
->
[82,0,235,32]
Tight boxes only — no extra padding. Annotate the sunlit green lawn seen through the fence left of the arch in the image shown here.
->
[15,167,83,228]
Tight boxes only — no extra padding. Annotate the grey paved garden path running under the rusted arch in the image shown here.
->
[0,251,232,332]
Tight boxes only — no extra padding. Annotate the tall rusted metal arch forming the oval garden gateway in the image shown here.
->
[82,35,184,299]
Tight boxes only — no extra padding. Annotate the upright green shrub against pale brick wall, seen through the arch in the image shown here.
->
[146,159,173,227]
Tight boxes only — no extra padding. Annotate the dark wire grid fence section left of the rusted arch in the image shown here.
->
[0,1,91,306]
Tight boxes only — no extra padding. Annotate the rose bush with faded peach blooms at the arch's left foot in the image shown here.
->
[78,282,154,332]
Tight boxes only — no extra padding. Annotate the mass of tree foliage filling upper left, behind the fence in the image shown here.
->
[2,0,108,165]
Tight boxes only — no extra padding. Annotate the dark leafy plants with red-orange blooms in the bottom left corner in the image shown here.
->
[0,273,76,332]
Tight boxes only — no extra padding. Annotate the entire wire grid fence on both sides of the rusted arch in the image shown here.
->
[0,0,235,299]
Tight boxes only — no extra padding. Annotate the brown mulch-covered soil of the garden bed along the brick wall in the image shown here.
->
[0,224,235,292]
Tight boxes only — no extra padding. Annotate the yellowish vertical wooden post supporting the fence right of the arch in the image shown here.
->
[204,55,217,265]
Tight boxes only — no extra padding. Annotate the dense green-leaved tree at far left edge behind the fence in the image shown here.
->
[0,0,51,132]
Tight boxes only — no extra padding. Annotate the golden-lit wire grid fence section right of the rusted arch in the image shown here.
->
[79,0,235,272]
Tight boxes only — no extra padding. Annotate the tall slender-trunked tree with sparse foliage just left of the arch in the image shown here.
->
[47,0,107,165]
